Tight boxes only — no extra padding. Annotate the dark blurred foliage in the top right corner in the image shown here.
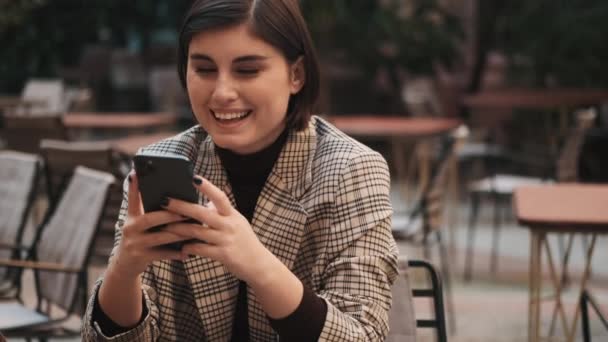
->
[496,0,608,87]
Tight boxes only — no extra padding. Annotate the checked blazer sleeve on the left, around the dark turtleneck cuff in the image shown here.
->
[81,179,159,342]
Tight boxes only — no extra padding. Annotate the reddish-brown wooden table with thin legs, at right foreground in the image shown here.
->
[513,184,608,341]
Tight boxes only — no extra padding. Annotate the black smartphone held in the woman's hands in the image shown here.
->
[133,151,198,250]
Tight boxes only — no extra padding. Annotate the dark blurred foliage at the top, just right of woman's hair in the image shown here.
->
[302,0,463,75]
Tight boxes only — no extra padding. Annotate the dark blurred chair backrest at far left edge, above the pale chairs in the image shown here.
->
[2,115,68,154]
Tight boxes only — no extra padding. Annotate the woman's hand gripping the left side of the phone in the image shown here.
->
[108,172,187,279]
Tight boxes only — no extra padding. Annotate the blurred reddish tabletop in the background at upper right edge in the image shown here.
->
[463,88,608,109]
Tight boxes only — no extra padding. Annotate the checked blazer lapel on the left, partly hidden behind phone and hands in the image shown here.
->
[184,138,238,341]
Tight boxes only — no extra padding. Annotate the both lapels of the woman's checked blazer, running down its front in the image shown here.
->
[179,117,317,340]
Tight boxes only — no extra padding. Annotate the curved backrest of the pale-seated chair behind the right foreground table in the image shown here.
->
[555,109,596,182]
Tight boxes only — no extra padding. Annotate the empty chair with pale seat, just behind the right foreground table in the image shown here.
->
[464,109,595,280]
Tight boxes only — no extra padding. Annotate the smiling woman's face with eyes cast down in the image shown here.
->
[186,24,304,154]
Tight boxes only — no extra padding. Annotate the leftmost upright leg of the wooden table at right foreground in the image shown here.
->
[528,230,545,342]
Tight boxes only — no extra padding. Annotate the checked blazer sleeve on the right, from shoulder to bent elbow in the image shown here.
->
[319,151,398,341]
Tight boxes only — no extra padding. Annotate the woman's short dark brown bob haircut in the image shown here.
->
[177,0,320,130]
